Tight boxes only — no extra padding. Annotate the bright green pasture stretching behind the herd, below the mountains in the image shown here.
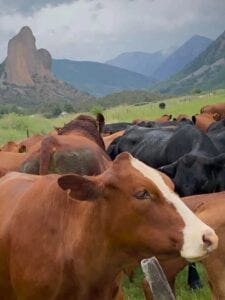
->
[0,90,225,143]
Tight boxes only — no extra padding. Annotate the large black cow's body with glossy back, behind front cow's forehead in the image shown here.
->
[107,125,219,168]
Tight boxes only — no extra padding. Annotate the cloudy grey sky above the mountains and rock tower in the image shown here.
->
[0,0,225,62]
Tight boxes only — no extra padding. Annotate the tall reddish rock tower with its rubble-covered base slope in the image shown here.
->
[0,26,94,106]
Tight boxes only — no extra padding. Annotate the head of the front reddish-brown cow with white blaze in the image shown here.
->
[58,153,217,260]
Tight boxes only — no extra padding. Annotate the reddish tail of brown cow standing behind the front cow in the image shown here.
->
[39,136,57,175]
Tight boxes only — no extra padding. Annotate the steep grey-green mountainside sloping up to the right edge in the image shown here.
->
[156,31,225,94]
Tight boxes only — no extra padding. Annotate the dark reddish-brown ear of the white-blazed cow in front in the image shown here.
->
[58,174,101,201]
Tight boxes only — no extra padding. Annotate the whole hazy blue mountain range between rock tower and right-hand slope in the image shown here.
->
[52,35,212,97]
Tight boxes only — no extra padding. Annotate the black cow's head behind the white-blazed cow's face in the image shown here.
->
[159,154,225,197]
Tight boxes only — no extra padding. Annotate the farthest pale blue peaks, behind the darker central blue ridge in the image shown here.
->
[106,35,212,81]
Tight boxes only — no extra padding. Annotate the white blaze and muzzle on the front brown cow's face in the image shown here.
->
[130,156,218,260]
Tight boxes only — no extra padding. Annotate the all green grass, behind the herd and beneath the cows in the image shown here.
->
[0,90,225,300]
